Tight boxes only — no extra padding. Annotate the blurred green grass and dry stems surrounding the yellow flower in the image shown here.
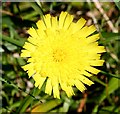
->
[0,0,120,114]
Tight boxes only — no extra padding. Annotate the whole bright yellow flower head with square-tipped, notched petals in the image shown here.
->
[21,12,105,98]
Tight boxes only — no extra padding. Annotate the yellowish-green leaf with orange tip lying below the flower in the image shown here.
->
[32,99,62,112]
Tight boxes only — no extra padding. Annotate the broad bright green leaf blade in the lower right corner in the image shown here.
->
[93,78,120,112]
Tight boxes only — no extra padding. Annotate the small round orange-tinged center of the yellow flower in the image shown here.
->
[53,49,65,62]
